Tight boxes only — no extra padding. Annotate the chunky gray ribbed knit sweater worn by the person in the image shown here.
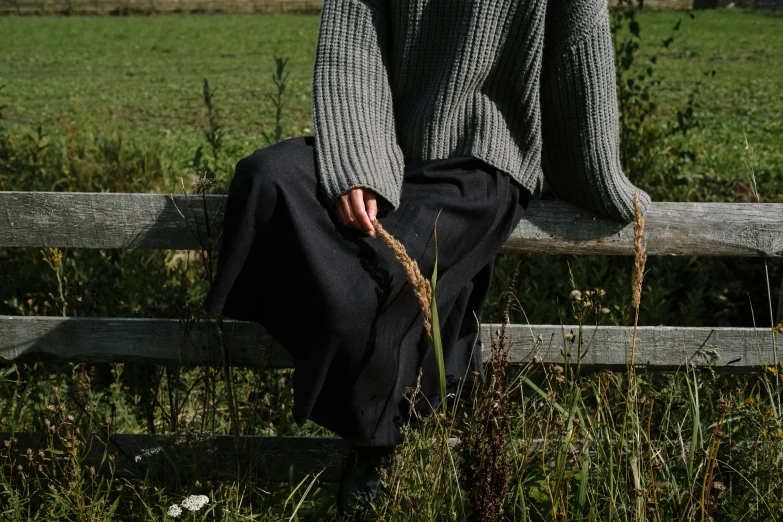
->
[313,0,650,221]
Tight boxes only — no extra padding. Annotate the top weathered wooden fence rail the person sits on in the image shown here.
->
[0,192,783,257]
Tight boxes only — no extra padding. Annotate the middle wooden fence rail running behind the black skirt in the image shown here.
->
[0,316,783,373]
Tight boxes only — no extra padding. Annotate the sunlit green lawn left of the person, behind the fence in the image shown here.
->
[0,15,319,173]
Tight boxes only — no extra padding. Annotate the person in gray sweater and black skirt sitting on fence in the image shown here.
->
[204,0,650,512]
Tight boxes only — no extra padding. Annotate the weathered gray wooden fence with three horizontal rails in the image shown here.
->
[0,192,783,481]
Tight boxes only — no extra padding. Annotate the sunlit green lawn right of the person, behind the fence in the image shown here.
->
[640,10,783,201]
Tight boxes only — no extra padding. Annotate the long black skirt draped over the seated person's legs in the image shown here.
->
[204,137,530,446]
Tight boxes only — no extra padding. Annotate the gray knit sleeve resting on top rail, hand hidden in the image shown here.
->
[541,0,650,222]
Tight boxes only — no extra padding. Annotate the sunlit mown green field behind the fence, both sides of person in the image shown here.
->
[0,10,783,199]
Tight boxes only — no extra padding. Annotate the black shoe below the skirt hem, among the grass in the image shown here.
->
[337,446,394,515]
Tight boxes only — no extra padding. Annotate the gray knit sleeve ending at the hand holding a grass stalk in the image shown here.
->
[313,0,404,209]
